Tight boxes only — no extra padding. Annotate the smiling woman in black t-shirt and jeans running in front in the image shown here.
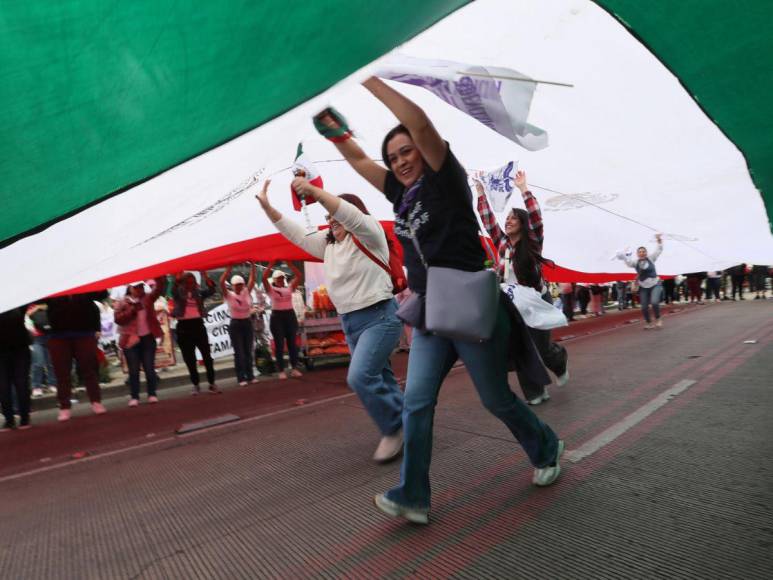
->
[315,77,563,524]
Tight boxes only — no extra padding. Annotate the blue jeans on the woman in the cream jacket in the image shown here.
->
[341,299,403,435]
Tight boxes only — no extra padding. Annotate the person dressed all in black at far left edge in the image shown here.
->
[0,306,31,432]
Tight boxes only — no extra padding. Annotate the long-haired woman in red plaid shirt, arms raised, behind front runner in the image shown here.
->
[475,171,569,405]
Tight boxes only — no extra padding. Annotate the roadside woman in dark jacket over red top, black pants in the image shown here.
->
[172,272,221,395]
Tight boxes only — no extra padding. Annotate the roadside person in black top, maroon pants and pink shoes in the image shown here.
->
[46,290,107,421]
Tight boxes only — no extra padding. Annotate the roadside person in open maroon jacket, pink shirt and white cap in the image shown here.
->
[114,277,166,407]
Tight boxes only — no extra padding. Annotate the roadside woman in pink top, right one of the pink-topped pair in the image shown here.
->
[263,262,303,379]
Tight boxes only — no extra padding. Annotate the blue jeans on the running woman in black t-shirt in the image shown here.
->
[386,305,558,508]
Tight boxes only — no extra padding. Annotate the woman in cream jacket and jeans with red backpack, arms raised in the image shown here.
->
[257,177,403,463]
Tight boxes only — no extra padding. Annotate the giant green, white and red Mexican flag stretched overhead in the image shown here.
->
[0,0,773,311]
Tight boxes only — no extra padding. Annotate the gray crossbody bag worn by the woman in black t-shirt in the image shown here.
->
[397,222,499,342]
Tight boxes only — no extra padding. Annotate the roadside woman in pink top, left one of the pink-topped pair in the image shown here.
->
[220,263,257,387]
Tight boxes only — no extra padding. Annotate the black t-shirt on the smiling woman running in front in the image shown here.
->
[384,147,486,294]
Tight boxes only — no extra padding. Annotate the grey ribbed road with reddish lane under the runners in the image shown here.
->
[0,302,773,579]
